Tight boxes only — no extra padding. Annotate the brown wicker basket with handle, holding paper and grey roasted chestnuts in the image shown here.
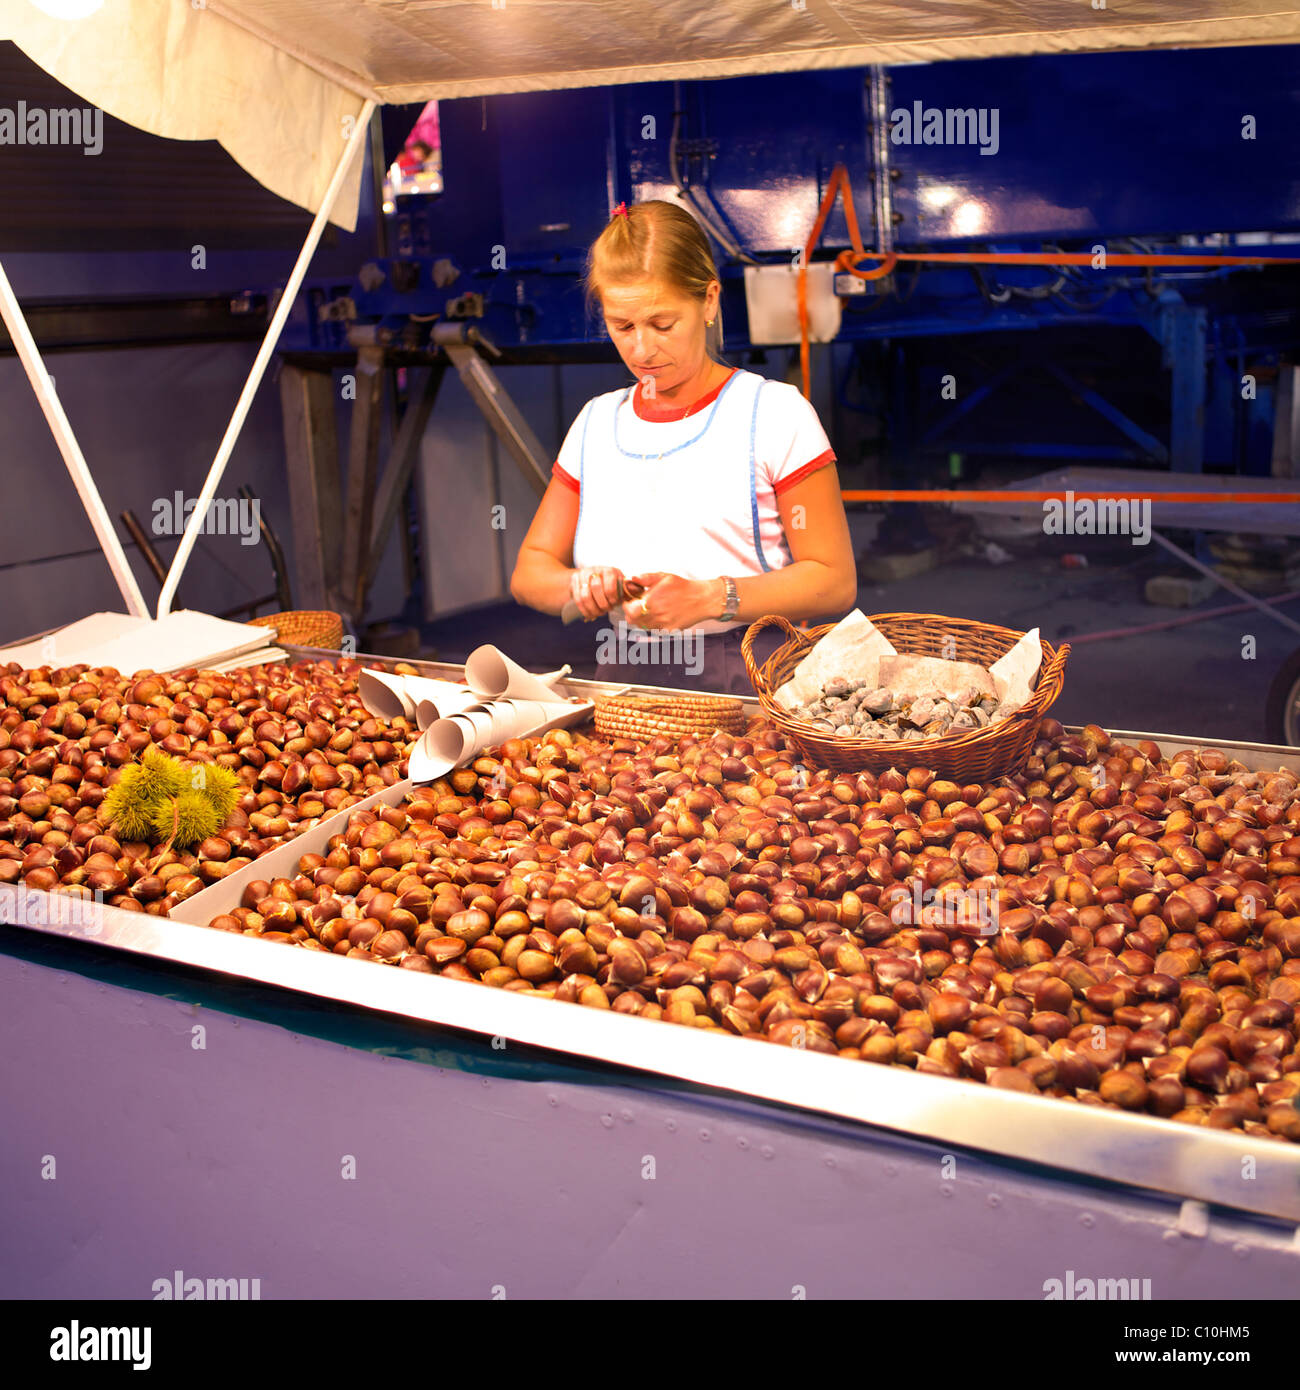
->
[741,613,1069,783]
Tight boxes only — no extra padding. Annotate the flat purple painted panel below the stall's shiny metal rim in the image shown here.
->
[0,945,1296,1295]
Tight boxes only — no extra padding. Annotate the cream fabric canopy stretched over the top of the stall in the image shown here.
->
[0,0,1300,229]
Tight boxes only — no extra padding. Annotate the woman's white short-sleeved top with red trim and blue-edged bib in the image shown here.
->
[552,370,836,632]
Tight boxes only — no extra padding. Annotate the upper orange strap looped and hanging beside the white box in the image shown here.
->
[798,164,1300,403]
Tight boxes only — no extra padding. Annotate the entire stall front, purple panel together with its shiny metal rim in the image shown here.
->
[0,656,1300,1300]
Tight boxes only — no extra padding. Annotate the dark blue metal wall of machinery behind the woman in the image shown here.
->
[295,47,1300,471]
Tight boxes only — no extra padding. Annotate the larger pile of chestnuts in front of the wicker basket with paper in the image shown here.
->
[200,719,1300,1141]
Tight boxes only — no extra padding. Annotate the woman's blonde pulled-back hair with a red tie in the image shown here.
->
[583,199,722,357]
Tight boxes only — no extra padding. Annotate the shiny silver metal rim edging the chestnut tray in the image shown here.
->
[0,648,1300,1222]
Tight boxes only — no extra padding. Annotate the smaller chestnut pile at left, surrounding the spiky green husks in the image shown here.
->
[0,660,416,913]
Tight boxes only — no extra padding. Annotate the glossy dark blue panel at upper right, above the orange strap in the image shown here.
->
[890,46,1300,243]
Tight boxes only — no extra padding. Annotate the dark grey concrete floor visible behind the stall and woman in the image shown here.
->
[423,512,1300,742]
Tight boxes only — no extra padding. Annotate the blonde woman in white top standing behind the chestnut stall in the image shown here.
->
[510,202,856,692]
